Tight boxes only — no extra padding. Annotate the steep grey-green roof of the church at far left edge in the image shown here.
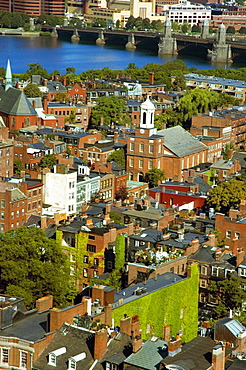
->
[0,87,37,116]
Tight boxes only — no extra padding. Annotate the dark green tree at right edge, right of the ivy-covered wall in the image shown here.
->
[209,276,246,317]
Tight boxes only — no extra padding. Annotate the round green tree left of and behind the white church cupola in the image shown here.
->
[91,96,130,127]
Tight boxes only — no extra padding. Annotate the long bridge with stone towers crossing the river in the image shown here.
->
[48,26,246,62]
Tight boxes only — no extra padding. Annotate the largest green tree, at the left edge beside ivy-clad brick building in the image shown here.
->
[0,227,71,308]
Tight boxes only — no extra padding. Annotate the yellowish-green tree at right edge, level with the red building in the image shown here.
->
[207,179,246,213]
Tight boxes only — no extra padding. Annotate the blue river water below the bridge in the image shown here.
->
[0,36,242,74]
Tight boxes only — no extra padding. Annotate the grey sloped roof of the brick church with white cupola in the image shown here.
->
[157,126,207,157]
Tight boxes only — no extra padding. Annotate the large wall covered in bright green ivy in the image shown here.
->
[113,265,199,342]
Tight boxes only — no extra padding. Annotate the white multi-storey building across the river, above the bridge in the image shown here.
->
[163,0,211,27]
